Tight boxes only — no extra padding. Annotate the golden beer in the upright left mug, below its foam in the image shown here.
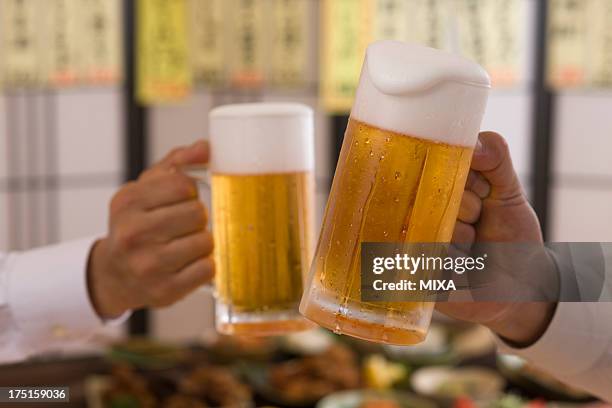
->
[212,172,313,334]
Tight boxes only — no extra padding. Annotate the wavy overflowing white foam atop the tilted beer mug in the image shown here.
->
[351,40,491,147]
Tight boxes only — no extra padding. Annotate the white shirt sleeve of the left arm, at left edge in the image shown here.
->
[0,239,127,362]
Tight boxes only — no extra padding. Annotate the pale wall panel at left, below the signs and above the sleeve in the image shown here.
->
[0,88,124,337]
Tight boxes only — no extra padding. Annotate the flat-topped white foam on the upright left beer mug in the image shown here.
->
[209,103,314,174]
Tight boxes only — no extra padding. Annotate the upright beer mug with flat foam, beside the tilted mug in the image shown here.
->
[209,103,314,335]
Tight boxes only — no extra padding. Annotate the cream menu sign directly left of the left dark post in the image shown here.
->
[79,0,122,84]
